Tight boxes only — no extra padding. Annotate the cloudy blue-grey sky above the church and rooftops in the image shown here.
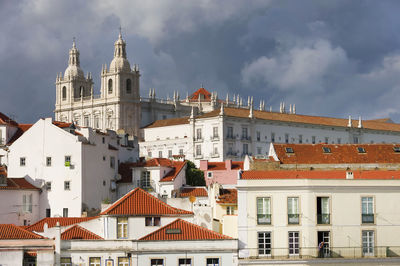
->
[0,0,400,122]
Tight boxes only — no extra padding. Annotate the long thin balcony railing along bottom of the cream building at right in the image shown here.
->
[239,243,400,260]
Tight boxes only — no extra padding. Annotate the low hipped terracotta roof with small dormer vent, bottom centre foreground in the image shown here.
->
[139,219,232,241]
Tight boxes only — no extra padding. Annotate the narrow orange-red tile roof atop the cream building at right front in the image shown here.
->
[241,170,400,180]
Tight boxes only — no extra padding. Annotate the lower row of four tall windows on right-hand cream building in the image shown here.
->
[257,230,375,257]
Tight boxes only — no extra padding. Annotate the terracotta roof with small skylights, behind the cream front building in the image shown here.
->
[273,143,400,164]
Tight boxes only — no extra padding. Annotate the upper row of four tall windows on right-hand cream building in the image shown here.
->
[257,197,375,225]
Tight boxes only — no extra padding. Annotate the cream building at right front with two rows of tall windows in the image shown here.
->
[237,170,400,265]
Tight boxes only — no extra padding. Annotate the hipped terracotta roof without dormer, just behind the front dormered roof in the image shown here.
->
[101,188,193,216]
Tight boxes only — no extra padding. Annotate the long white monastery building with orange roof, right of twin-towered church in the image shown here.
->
[140,106,400,164]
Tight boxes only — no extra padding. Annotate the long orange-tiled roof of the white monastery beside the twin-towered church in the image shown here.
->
[145,107,400,132]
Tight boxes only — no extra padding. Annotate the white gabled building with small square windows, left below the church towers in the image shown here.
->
[8,118,138,218]
